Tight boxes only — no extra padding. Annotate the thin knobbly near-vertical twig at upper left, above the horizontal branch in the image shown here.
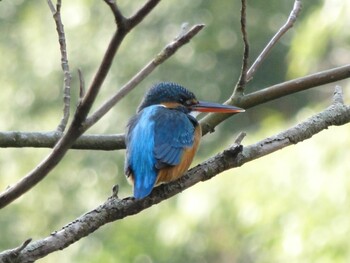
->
[47,0,72,132]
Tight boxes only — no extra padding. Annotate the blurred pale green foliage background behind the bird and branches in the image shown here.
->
[0,0,350,263]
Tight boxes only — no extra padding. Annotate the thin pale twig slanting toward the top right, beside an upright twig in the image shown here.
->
[247,0,302,81]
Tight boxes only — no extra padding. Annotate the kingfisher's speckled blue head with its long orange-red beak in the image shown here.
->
[137,82,244,113]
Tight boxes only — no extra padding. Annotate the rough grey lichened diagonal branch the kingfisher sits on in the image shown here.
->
[0,87,350,262]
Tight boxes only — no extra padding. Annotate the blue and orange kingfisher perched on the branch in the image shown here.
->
[125,82,244,199]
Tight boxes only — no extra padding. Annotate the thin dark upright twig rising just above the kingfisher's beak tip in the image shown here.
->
[232,0,249,96]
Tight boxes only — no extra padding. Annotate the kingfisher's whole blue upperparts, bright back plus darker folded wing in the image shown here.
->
[125,105,198,198]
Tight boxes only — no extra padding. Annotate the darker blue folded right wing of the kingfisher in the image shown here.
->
[154,108,196,169]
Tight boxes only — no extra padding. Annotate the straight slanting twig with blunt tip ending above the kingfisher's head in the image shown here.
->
[84,24,204,129]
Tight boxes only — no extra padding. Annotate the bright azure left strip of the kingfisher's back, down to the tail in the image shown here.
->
[125,106,159,199]
